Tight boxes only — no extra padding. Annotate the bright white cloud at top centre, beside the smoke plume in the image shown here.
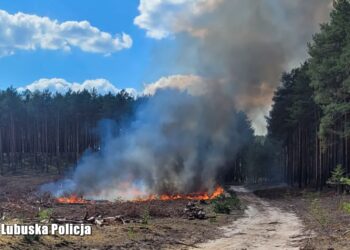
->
[134,0,223,39]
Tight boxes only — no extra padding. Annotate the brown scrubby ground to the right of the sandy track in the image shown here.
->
[255,188,350,250]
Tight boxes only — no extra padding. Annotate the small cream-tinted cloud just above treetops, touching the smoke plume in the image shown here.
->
[143,75,206,95]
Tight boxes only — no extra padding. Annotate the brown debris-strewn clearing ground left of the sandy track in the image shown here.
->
[0,176,243,249]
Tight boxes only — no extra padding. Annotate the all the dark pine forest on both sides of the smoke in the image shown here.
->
[0,0,350,191]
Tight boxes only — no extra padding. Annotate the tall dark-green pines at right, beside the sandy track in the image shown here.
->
[268,0,350,188]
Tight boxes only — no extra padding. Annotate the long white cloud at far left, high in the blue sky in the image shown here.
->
[0,10,132,56]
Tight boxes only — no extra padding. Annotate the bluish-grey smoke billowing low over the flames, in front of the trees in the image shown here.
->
[44,90,252,199]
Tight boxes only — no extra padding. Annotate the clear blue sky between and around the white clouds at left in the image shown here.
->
[0,0,178,90]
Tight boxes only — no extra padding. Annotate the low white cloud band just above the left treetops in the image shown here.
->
[18,78,137,96]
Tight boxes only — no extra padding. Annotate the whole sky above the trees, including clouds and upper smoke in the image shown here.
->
[0,0,324,135]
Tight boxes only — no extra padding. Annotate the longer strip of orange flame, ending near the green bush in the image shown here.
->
[134,187,224,202]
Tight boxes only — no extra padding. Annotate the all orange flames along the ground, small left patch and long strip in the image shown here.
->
[57,186,224,204]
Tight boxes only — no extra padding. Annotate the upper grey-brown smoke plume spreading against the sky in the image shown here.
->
[155,0,332,134]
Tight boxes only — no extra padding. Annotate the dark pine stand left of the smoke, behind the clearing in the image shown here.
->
[0,88,138,174]
